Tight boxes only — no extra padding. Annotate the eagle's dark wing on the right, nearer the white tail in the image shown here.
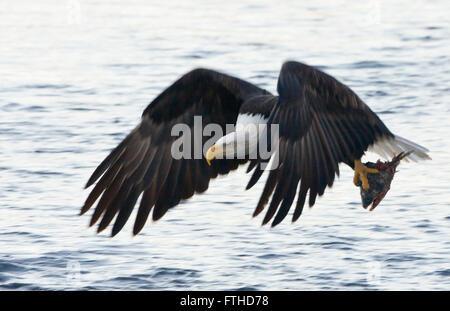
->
[251,62,394,226]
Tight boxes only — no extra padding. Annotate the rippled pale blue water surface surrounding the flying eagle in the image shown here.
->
[0,0,450,290]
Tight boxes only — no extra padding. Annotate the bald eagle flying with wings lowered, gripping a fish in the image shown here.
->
[80,61,429,236]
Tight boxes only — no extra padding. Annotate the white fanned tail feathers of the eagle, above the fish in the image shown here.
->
[368,136,431,162]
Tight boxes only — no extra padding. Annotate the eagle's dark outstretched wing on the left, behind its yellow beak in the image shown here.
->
[81,69,268,235]
